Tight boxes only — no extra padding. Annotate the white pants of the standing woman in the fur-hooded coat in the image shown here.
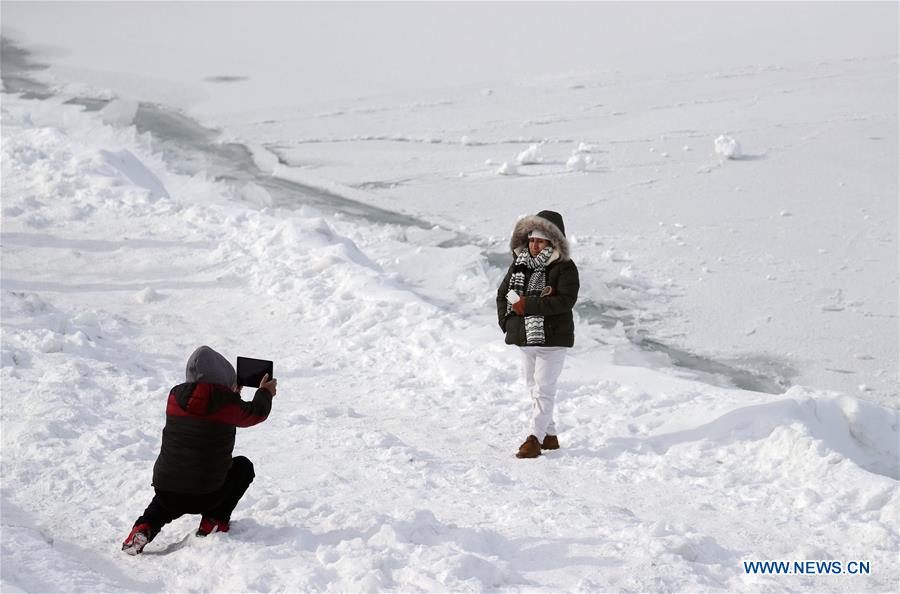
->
[519,347,568,442]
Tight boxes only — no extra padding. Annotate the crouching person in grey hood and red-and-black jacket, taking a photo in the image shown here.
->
[122,346,278,555]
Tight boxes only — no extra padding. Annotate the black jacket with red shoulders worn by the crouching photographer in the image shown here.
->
[153,383,272,493]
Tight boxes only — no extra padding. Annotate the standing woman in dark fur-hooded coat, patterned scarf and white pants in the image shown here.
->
[497,210,579,458]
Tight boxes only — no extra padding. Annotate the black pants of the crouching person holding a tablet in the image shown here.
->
[134,456,256,540]
